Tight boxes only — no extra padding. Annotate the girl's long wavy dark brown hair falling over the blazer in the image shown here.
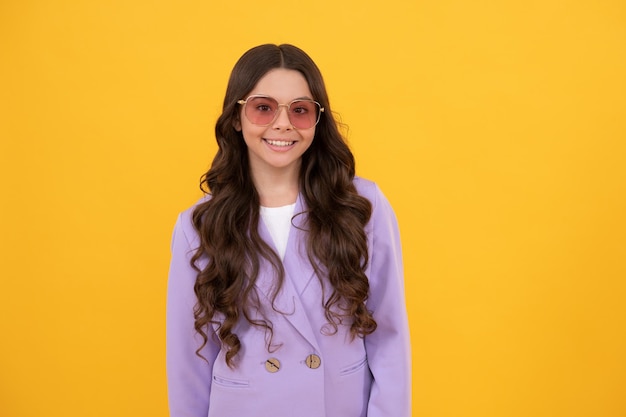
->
[191,44,376,367]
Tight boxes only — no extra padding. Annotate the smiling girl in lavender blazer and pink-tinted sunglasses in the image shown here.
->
[167,44,411,417]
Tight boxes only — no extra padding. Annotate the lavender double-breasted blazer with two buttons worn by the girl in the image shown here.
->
[167,178,411,417]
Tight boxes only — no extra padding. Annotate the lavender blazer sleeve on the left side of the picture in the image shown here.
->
[166,212,219,417]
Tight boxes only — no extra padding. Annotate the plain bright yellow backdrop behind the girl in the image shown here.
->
[0,0,626,417]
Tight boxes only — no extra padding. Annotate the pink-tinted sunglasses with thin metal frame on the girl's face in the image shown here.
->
[237,94,324,129]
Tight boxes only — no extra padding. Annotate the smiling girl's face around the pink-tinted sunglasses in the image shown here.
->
[235,68,315,174]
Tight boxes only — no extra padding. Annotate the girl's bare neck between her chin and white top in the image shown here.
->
[252,165,300,207]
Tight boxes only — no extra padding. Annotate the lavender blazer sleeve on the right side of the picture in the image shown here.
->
[365,186,411,417]
